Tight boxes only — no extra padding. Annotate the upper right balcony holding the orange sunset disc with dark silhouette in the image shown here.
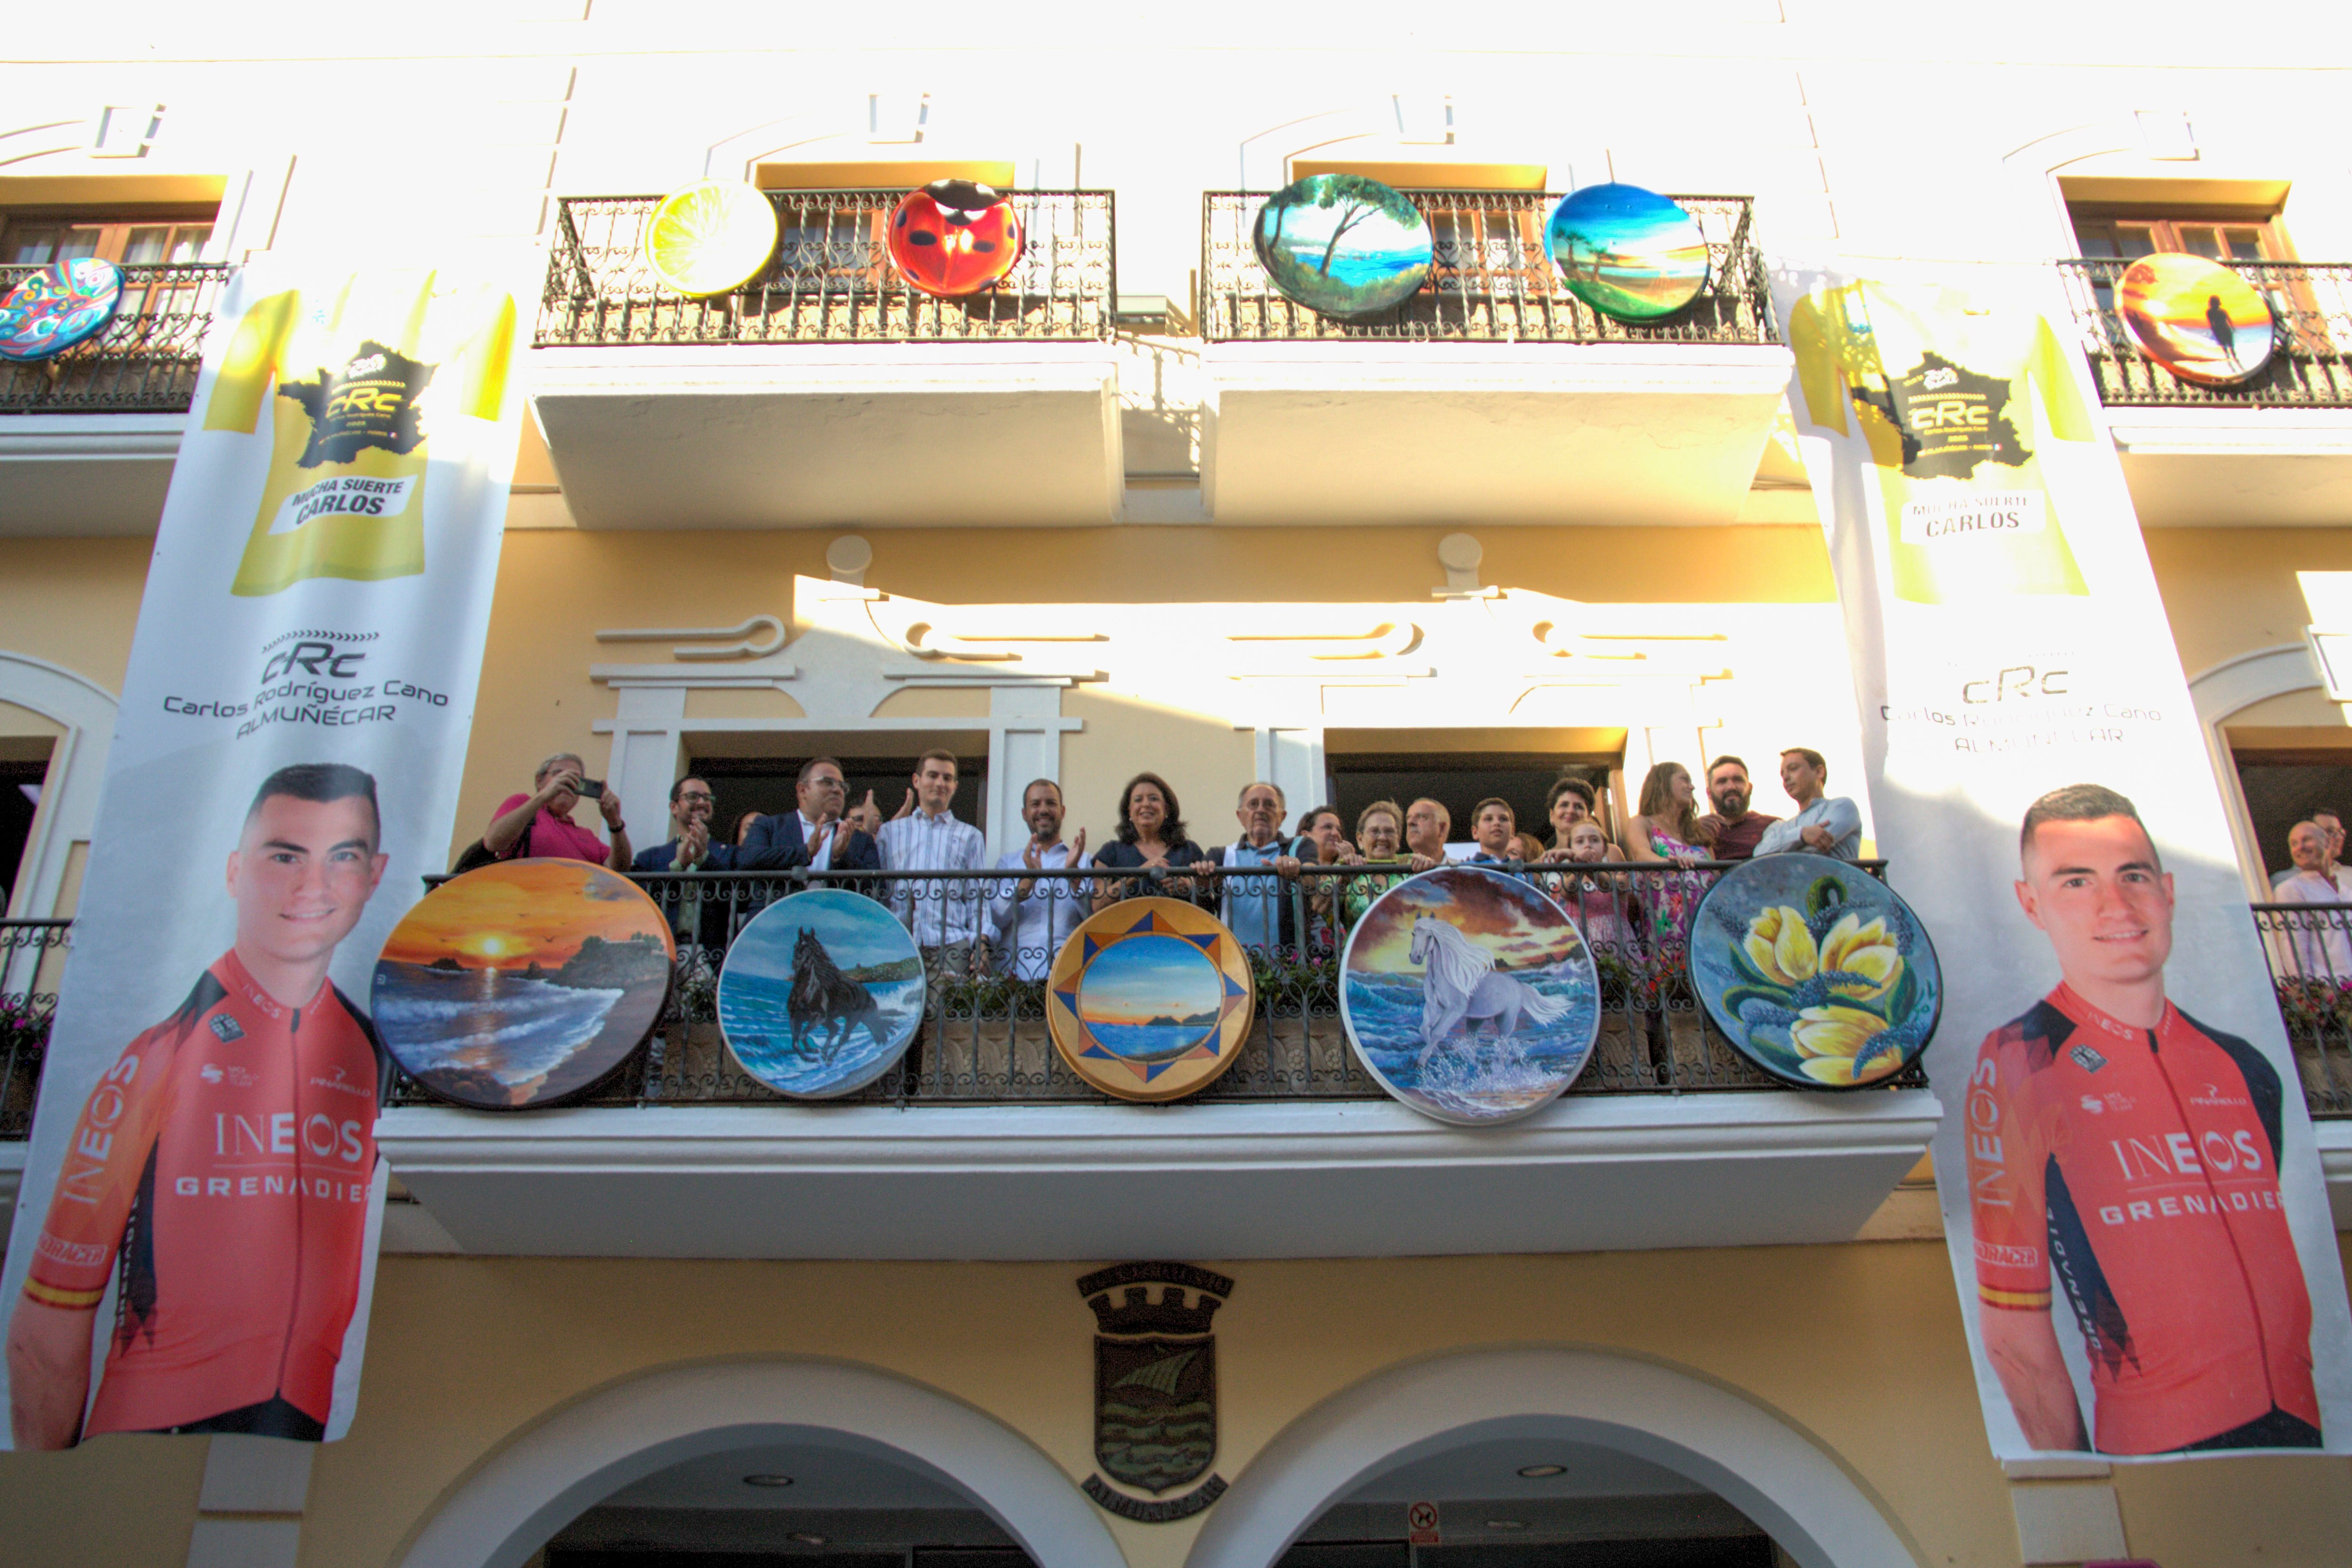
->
[2058,256,2352,526]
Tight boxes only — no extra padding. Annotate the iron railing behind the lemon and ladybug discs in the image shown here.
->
[532,191,1117,348]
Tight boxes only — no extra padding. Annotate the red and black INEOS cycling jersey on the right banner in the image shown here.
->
[1966,985,2319,1453]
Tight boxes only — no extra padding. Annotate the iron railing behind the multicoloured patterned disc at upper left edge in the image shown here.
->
[0,261,228,414]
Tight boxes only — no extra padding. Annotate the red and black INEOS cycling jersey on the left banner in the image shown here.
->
[24,952,388,1436]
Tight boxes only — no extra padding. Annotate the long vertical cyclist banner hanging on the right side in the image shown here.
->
[1778,275,2352,1460]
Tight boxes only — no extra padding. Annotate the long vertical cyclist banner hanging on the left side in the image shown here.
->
[0,268,522,1448]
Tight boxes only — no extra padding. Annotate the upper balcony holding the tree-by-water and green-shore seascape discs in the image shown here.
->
[1200,191,1790,524]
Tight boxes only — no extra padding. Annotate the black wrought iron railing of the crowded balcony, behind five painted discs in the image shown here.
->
[393,863,1926,1105]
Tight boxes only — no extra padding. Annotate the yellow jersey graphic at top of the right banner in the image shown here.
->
[1790,282,2091,604]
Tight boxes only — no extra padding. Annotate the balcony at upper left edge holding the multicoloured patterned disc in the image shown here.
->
[0,261,228,533]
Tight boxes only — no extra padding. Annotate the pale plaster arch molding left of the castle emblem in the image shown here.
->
[400,1361,1127,1568]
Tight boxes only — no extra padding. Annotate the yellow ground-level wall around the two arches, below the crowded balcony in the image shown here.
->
[0,1241,2352,1568]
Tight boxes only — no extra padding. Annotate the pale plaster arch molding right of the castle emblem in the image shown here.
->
[1185,1349,1922,1568]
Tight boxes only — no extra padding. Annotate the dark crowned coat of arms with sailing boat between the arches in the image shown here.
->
[1077,1262,1232,1523]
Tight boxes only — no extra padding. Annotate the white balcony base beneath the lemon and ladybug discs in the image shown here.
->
[532,343,1122,529]
